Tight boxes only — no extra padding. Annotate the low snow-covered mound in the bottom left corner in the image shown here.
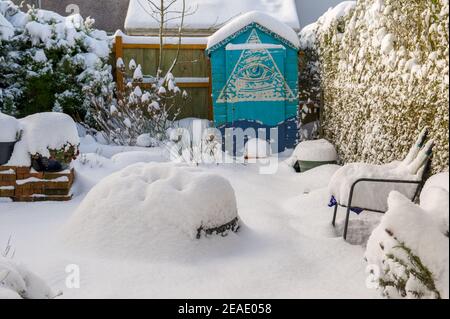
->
[0,255,56,299]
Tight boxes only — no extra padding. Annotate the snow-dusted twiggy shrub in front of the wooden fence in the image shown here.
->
[85,58,184,146]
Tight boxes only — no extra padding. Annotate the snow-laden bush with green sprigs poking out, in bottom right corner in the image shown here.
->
[365,189,449,298]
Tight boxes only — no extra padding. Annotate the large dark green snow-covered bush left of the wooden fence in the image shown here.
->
[0,1,113,121]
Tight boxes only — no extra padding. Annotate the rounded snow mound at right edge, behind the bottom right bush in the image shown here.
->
[420,172,449,234]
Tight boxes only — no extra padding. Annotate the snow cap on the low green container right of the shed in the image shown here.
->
[294,139,337,162]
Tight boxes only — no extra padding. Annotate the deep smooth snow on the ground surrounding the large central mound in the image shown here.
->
[0,138,378,298]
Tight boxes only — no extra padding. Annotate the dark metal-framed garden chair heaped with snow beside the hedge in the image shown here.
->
[328,129,434,239]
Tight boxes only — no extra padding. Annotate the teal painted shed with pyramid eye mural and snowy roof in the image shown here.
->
[207,12,299,151]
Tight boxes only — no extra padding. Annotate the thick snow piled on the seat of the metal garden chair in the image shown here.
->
[328,161,424,212]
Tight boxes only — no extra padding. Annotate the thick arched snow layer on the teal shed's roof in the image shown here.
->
[207,11,300,50]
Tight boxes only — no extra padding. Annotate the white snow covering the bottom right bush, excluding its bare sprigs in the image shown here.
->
[365,192,449,298]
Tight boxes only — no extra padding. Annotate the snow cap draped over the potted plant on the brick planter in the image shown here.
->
[7,112,80,166]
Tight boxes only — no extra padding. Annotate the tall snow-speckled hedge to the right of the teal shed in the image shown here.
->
[300,0,449,172]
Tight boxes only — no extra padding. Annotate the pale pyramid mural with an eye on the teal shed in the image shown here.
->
[217,30,296,103]
